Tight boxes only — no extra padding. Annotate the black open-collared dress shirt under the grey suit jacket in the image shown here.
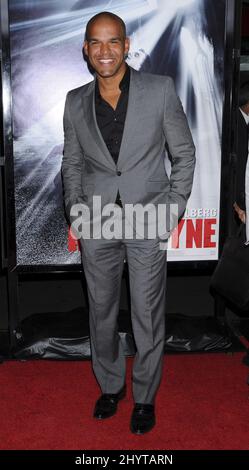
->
[95,66,130,207]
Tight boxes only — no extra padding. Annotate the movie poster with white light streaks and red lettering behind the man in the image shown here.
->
[9,0,226,265]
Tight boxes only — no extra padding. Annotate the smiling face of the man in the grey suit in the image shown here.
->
[84,17,129,78]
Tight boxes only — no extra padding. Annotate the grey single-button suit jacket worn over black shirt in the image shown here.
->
[62,68,195,232]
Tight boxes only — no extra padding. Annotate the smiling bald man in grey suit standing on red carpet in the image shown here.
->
[62,12,195,434]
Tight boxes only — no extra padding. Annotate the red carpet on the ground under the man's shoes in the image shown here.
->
[0,353,249,450]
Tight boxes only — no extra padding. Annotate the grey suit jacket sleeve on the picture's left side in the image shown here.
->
[61,94,84,221]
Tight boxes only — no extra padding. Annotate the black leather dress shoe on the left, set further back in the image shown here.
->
[93,385,126,419]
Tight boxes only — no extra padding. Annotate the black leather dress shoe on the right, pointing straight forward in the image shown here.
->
[130,403,156,434]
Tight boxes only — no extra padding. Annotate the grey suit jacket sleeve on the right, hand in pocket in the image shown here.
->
[164,77,195,222]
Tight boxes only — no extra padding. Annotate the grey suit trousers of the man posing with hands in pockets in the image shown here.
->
[81,228,167,404]
